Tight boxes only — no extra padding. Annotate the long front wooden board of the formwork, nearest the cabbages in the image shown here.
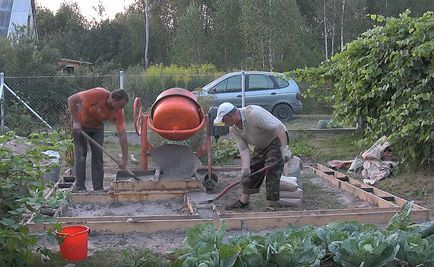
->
[27,210,429,233]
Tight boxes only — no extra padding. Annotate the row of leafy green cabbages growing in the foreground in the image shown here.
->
[173,203,434,267]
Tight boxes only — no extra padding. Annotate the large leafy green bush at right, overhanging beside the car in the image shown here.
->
[294,11,434,170]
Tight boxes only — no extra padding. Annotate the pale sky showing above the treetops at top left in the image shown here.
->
[36,0,133,21]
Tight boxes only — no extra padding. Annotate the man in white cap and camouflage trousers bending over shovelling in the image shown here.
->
[214,102,291,209]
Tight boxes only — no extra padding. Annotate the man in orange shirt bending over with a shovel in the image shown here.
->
[68,87,129,191]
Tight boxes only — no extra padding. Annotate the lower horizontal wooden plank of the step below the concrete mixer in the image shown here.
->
[71,191,185,203]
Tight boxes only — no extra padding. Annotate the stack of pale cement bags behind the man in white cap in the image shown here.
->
[280,157,303,206]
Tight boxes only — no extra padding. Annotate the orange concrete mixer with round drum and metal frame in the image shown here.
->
[133,88,215,188]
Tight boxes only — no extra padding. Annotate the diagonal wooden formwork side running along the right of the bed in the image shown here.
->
[312,168,398,208]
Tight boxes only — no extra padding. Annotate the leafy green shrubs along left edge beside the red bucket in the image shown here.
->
[0,132,71,266]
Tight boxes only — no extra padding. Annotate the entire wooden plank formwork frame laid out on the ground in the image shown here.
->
[27,164,430,236]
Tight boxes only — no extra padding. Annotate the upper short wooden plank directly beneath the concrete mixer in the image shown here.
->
[111,180,204,191]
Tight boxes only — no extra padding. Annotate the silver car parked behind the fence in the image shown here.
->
[201,71,303,121]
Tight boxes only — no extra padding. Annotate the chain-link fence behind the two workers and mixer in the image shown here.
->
[0,71,332,135]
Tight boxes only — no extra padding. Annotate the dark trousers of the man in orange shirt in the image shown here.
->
[73,126,104,190]
